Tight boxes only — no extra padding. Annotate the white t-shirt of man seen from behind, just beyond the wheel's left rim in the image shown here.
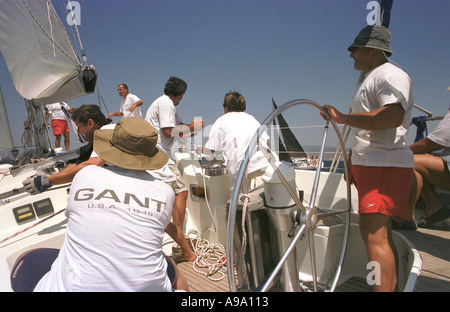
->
[205,112,269,186]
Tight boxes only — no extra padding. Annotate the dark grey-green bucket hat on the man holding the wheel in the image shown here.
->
[347,25,392,57]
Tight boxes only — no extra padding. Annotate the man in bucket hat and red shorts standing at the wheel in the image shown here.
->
[323,25,414,291]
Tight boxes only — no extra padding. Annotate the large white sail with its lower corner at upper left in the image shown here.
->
[0,0,97,105]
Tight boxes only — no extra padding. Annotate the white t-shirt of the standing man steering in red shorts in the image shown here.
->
[351,63,414,168]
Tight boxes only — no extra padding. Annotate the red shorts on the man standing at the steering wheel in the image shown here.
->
[352,165,414,218]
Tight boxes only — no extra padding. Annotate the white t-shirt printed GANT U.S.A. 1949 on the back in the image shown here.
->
[35,166,175,292]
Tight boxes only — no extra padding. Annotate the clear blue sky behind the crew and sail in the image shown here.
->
[0,0,450,153]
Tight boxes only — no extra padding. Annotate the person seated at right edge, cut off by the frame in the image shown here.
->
[393,110,450,230]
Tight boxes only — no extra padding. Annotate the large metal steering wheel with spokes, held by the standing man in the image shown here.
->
[226,100,351,291]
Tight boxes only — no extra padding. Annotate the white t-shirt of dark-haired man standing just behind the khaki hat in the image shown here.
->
[145,95,181,157]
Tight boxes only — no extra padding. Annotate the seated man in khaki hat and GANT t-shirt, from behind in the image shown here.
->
[11,117,188,291]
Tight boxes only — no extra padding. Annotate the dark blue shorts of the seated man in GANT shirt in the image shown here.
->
[11,248,175,292]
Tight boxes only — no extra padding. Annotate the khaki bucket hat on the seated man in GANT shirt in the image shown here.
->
[94,117,169,170]
